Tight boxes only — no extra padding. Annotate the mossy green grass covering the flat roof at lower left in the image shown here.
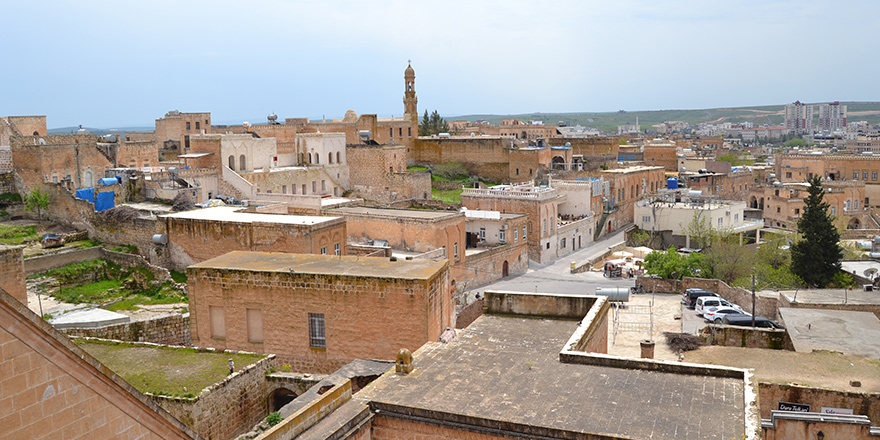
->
[74,339,265,397]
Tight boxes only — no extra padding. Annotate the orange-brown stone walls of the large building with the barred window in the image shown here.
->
[187,262,453,373]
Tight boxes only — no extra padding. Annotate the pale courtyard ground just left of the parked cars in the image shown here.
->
[608,293,681,361]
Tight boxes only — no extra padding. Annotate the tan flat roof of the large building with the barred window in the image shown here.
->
[190,251,446,280]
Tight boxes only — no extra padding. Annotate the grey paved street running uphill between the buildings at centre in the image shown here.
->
[476,229,635,295]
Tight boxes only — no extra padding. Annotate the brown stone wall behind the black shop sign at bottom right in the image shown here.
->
[758,382,880,426]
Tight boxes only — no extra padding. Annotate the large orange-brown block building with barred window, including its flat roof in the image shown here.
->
[187,252,454,373]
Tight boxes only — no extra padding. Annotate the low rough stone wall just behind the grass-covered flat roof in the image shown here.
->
[61,313,192,347]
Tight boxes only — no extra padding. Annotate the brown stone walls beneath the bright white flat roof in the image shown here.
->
[163,215,346,268]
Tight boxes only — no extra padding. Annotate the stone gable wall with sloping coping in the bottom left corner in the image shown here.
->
[0,286,201,440]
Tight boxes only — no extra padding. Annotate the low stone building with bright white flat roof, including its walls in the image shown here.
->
[160,206,347,268]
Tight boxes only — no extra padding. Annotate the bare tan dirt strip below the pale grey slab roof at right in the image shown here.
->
[684,346,880,392]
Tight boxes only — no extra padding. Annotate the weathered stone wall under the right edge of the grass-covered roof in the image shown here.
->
[147,355,276,439]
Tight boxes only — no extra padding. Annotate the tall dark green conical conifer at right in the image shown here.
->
[791,176,843,287]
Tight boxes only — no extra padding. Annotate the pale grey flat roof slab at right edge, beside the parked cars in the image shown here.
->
[779,307,880,359]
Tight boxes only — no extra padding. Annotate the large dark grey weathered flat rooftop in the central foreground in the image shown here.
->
[358,315,745,440]
